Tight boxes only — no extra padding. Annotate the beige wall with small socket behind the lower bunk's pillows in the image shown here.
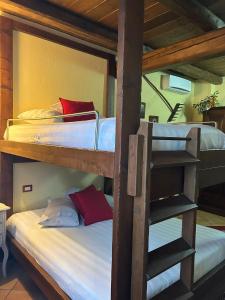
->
[13,163,103,212]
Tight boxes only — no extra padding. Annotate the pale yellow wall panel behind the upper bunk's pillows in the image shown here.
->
[13,32,107,116]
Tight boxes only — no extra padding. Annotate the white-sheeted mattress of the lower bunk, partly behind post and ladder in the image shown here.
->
[7,210,225,300]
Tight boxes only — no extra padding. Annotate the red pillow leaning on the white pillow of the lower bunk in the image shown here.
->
[69,185,113,225]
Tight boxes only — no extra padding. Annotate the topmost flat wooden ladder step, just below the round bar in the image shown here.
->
[152,151,200,168]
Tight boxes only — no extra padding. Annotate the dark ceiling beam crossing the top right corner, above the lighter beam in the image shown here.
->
[159,0,225,31]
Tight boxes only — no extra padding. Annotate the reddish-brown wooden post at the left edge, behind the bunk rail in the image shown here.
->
[0,16,13,214]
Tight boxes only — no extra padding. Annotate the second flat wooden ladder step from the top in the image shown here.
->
[150,195,198,224]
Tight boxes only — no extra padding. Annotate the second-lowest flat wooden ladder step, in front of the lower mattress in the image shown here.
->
[147,238,195,280]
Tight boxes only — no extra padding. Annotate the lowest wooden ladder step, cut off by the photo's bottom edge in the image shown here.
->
[152,280,194,300]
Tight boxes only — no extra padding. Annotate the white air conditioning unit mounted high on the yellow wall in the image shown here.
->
[161,75,191,94]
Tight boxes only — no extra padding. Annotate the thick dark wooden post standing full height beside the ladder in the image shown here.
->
[112,0,144,300]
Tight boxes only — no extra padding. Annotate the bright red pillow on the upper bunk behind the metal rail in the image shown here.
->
[59,98,95,122]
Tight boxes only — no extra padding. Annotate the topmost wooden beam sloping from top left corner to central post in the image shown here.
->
[0,0,117,50]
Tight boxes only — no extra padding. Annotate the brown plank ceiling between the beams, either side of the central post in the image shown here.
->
[48,0,203,48]
